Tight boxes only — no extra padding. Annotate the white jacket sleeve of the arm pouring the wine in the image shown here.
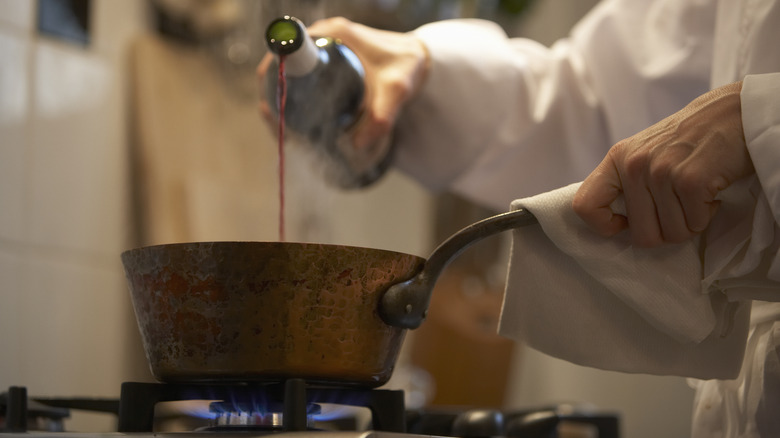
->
[395,0,715,209]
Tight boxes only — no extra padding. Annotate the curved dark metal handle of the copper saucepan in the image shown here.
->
[379,209,538,329]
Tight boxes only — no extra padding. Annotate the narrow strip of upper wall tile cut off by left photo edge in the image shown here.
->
[0,30,29,241]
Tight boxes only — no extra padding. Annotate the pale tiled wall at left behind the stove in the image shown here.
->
[0,0,151,429]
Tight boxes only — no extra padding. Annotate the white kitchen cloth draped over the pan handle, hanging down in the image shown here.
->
[499,180,778,379]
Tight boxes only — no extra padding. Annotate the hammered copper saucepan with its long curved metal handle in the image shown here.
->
[122,210,536,387]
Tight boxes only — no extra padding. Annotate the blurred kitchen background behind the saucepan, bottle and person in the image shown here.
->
[0,0,692,438]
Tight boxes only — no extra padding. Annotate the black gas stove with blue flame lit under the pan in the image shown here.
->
[0,379,619,438]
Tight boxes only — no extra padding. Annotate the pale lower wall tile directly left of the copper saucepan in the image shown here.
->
[16,256,130,396]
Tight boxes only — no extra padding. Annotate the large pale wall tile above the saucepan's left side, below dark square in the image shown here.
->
[28,42,128,255]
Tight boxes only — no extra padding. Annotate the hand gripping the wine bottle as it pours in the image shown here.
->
[257,17,429,150]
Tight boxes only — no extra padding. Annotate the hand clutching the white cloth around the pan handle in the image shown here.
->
[572,82,754,247]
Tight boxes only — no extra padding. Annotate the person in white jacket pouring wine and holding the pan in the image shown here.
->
[258,0,780,437]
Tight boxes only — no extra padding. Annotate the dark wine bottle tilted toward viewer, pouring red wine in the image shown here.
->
[266,16,392,188]
